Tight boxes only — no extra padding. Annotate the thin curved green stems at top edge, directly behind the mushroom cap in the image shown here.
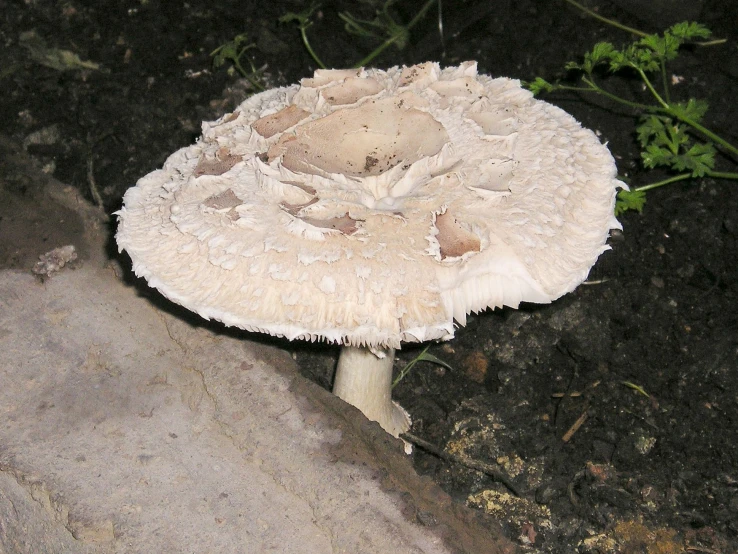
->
[279,0,434,69]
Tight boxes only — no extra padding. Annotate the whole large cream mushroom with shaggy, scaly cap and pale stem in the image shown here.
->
[116,62,623,436]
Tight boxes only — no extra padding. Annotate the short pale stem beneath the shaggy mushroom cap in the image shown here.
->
[333,346,410,437]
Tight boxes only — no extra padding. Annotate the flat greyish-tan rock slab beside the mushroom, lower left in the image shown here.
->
[0,143,510,554]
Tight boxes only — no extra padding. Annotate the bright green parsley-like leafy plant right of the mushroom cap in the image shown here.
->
[527,19,738,214]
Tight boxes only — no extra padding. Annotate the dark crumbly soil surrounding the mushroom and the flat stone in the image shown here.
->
[0,0,738,554]
